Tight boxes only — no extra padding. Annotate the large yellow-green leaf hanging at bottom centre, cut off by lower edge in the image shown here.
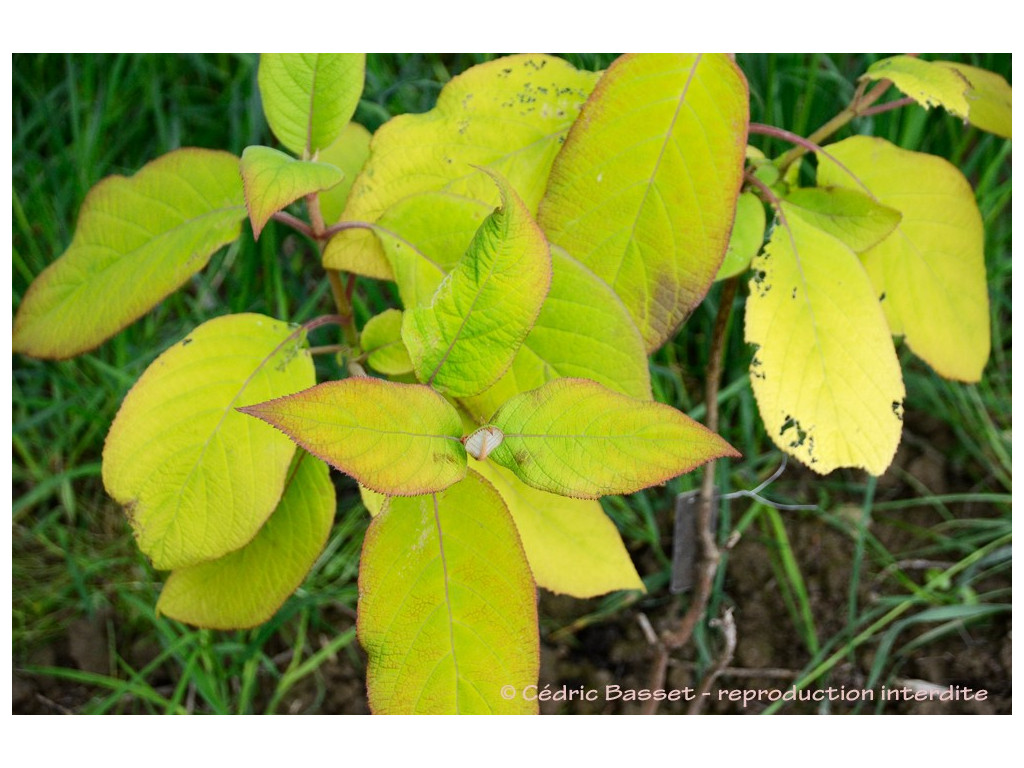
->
[358,472,540,715]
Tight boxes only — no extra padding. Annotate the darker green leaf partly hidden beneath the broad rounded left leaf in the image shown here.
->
[157,452,335,630]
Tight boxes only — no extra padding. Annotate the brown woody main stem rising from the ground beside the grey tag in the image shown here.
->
[644,278,739,715]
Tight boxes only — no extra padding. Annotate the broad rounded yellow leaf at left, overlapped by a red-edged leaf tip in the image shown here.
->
[103,314,314,570]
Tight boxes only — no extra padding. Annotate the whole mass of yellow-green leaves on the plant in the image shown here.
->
[14,54,1009,712]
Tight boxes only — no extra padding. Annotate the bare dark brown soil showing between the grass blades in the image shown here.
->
[13,414,1012,714]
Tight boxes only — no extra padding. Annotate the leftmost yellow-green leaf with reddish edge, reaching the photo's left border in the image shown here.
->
[13,150,246,359]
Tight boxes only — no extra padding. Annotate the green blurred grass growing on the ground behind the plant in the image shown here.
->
[12,54,1012,713]
